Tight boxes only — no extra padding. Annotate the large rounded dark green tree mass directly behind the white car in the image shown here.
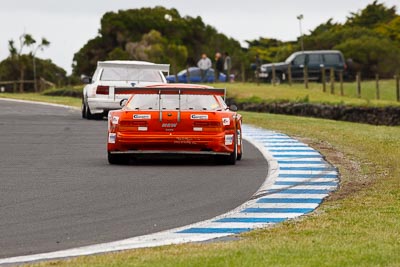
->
[73,6,244,76]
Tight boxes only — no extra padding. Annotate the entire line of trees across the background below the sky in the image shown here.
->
[0,1,400,90]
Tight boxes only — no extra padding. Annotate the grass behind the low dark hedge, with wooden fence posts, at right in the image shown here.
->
[219,80,400,106]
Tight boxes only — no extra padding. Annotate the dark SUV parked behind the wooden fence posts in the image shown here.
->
[259,50,347,83]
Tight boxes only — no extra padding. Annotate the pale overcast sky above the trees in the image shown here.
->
[0,0,400,73]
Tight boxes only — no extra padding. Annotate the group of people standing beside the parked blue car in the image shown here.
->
[197,52,232,82]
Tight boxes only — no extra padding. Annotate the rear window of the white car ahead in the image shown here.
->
[100,67,163,82]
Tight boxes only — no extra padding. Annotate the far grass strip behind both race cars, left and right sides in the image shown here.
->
[0,80,400,106]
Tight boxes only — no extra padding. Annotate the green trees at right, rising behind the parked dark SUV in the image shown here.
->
[248,1,400,78]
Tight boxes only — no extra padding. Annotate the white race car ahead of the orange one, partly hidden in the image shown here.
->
[82,60,169,119]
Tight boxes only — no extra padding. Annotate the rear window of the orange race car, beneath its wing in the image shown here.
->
[127,94,222,110]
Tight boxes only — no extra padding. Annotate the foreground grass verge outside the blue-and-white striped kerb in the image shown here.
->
[26,112,400,266]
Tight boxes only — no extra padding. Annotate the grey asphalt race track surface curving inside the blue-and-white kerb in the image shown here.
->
[0,100,267,258]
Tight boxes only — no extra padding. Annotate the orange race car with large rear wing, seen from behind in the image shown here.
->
[107,84,243,165]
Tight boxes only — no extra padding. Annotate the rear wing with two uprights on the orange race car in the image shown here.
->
[115,87,226,122]
